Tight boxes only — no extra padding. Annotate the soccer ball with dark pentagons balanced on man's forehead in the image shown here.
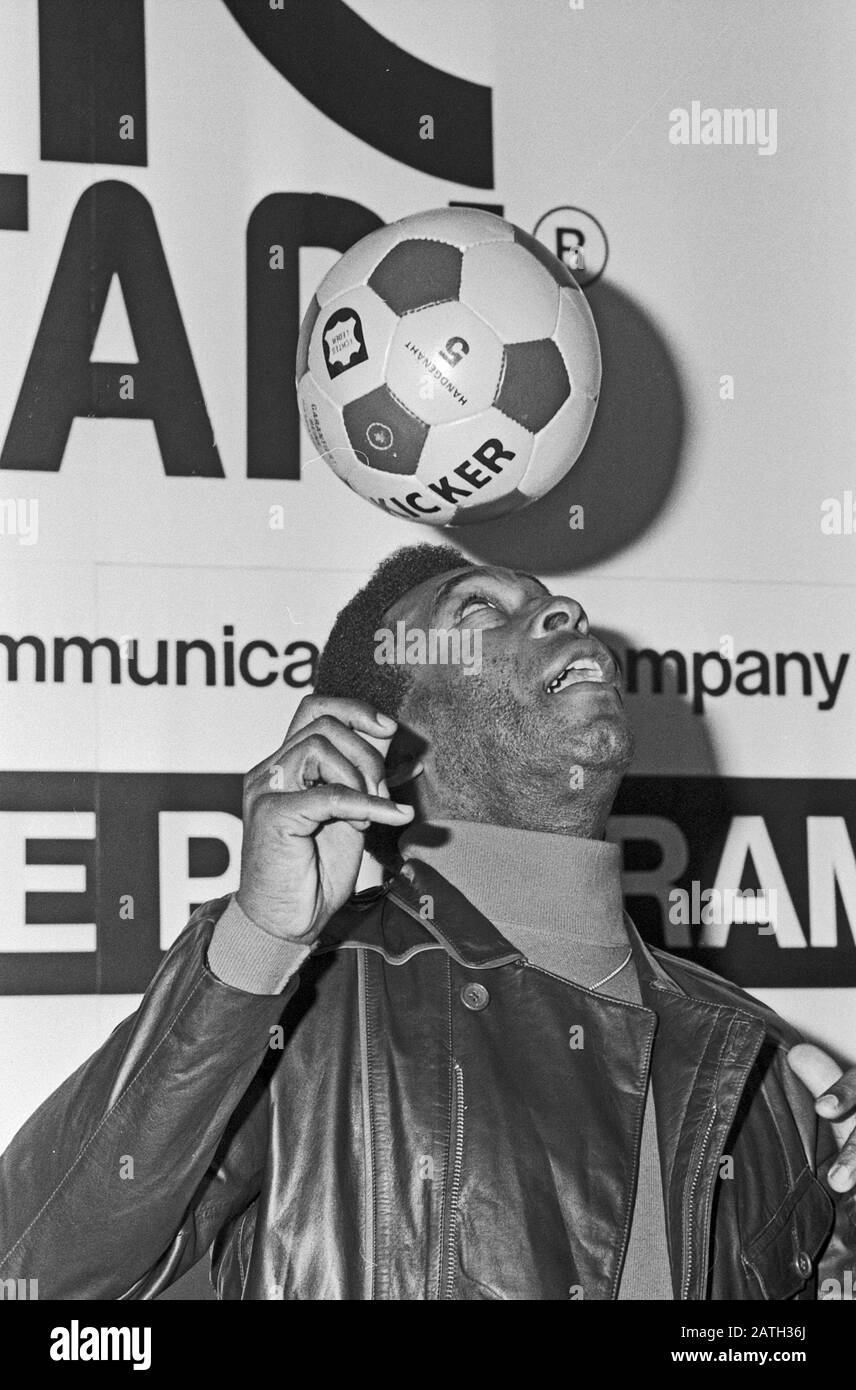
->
[297,209,600,525]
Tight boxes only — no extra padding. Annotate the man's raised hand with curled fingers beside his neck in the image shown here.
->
[236,695,413,945]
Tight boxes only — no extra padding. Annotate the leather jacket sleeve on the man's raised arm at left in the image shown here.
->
[0,899,305,1300]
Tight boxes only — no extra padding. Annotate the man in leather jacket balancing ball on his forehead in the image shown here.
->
[0,545,856,1300]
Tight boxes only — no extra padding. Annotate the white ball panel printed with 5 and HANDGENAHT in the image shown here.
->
[386,300,503,424]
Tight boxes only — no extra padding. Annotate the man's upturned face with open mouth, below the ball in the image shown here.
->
[385,566,632,823]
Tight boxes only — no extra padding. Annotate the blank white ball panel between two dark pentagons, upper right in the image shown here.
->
[460,242,559,343]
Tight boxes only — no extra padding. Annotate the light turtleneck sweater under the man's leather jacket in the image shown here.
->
[399,820,674,1300]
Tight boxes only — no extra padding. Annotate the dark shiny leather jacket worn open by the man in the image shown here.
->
[0,860,856,1300]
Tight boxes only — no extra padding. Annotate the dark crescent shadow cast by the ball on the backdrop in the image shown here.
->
[458,281,685,574]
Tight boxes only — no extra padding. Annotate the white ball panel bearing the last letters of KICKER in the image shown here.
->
[418,409,532,509]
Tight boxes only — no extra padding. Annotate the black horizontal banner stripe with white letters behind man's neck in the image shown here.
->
[0,771,856,994]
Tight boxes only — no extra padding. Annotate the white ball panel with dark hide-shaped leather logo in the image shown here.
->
[308,285,397,406]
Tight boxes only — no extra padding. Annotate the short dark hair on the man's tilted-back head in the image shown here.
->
[314,542,471,719]
